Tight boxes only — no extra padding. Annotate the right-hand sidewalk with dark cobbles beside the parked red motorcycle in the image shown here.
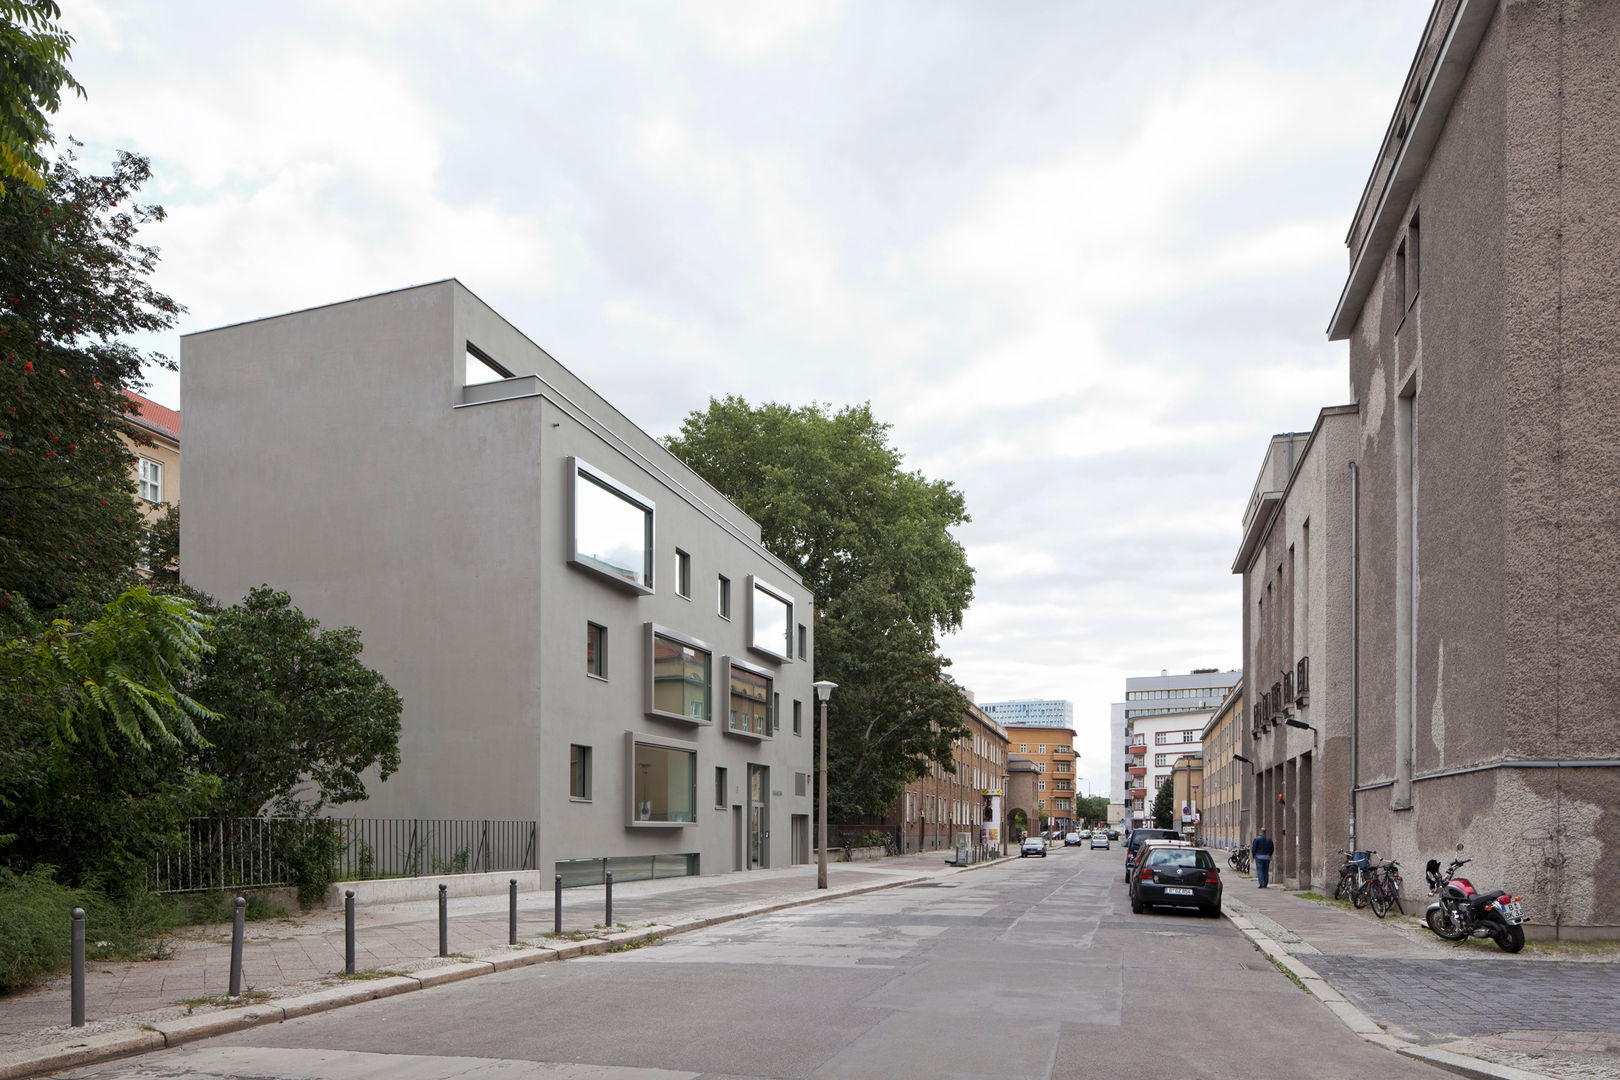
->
[1221,871,1620,1080]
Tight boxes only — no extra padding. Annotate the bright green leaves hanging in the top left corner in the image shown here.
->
[0,0,84,201]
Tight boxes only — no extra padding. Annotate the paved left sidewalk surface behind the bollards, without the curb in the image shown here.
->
[0,852,959,1057]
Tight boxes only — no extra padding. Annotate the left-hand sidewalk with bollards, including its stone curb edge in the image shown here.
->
[0,852,995,1080]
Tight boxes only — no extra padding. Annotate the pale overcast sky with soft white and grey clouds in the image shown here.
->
[57,0,1429,803]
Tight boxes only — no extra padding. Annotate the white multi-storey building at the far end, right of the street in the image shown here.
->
[1108,667,1243,827]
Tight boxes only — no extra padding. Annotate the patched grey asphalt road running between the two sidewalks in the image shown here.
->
[57,848,1450,1080]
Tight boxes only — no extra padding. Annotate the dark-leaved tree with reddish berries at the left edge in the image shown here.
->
[0,143,180,612]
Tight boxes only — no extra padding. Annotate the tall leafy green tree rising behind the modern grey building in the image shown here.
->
[664,397,974,821]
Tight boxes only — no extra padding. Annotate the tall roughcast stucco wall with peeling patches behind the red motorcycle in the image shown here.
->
[1349,0,1620,934]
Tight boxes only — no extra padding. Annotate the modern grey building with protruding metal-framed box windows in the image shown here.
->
[181,280,813,879]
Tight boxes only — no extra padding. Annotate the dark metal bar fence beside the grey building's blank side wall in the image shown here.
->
[154,818,536,892]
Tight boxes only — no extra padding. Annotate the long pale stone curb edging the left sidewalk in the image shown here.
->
[0,860,939,1080]
